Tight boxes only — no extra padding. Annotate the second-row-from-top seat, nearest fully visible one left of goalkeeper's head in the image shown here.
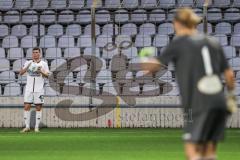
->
[149,9,166,23]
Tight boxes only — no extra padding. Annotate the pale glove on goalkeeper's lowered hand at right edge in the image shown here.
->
[227,90,238,114]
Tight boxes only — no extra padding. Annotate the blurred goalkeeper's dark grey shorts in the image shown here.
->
[183,108,227,143]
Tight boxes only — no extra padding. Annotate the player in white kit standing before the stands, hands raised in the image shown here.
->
[19,47,49,132]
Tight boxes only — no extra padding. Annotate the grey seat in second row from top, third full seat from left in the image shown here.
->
[40,10,57,24]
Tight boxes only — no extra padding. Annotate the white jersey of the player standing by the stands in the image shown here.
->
[23,60,49,93]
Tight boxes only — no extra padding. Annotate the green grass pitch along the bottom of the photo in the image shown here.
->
[0,128,240,160]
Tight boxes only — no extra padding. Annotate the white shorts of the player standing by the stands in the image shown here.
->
[24,92,44,104]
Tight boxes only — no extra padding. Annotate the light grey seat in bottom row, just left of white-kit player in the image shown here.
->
[3,83,21,96]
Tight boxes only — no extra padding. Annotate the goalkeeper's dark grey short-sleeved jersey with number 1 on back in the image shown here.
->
[158,34,228,113]
